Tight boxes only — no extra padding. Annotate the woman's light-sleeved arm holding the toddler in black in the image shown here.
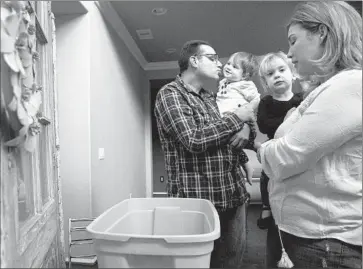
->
[260,76,362,179]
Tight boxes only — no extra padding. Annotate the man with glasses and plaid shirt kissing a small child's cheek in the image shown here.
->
[154,40,256,268]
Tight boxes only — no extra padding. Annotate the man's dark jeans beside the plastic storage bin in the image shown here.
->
[210,204,248,268]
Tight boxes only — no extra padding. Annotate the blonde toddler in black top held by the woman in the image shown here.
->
[257,52,303,229]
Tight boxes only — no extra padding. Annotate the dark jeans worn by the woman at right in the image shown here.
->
[266,226,362,268]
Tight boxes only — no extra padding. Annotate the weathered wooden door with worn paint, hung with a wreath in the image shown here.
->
[0,1,65,268]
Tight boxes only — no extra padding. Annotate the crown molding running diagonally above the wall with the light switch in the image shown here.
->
[96,1,148,69]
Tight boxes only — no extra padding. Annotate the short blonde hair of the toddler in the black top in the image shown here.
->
[258,51,297,92]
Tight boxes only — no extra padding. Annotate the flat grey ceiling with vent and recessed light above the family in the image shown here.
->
[110,0,362,64]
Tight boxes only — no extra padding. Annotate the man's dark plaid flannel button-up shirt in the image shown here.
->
[154,76,256,211]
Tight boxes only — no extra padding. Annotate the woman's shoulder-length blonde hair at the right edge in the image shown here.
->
[287,1,362,75]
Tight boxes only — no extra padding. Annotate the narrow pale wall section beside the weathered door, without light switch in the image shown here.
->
[56,12,92,260]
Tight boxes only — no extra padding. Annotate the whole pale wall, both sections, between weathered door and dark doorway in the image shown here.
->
[56,2,149,260]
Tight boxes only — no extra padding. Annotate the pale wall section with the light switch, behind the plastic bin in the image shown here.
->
[89,3,149,216]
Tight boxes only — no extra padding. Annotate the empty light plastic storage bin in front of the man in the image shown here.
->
[87,198,220,268]
